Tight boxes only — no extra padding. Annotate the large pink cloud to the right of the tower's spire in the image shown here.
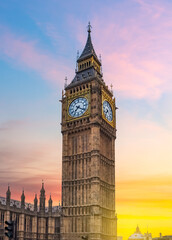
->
[71,0,172,100]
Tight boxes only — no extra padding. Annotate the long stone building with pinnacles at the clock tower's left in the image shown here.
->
[0,184,61,240]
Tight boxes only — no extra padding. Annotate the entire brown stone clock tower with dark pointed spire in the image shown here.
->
[61,24,117,240]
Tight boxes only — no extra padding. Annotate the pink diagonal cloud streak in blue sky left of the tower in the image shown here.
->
[0,27,71,84]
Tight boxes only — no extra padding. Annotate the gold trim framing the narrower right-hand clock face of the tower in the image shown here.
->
[102,87,115,128]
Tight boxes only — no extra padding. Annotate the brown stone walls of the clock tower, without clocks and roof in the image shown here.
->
[61,73,116,240]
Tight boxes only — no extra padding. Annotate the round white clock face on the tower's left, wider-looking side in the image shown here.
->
[69,97,88,117]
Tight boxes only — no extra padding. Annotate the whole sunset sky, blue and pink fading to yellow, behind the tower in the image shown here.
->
[0,0,172,240]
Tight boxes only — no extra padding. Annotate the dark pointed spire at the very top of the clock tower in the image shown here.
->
[77,22,101,65]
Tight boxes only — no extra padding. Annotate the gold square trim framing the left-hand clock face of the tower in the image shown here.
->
[66,89,91,122]
